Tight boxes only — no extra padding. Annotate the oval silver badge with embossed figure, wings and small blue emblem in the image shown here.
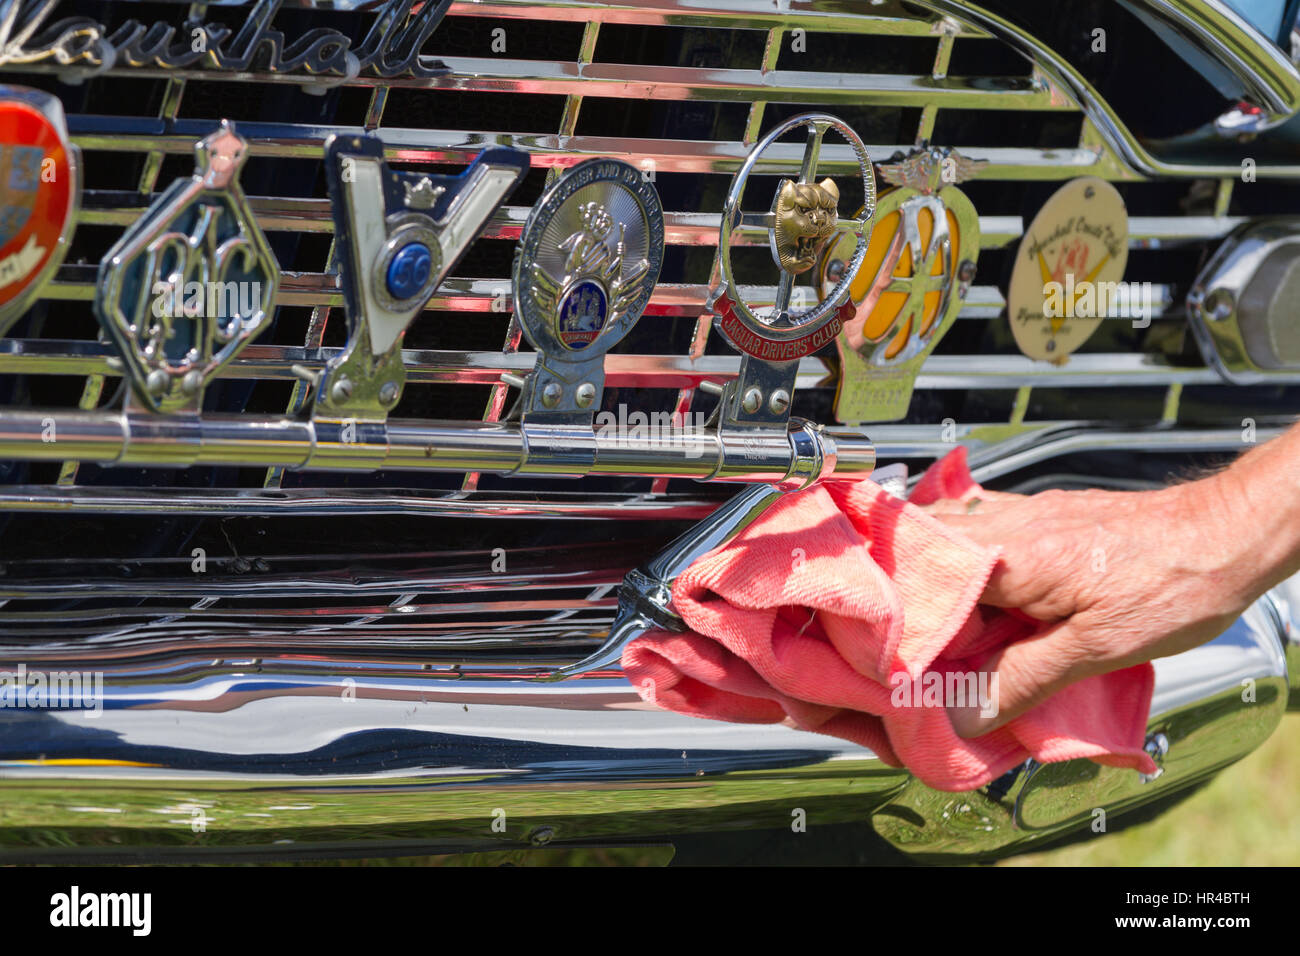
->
[514,159,664,423]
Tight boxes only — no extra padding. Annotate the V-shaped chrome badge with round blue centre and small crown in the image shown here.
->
[312,135,529,421]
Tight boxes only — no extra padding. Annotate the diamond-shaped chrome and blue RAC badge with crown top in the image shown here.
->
[95,121,280,414]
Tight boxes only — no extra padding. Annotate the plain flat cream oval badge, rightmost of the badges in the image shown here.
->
[1006,177,1128,364]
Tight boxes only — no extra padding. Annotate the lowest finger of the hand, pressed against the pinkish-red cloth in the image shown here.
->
[948,620,1095,739]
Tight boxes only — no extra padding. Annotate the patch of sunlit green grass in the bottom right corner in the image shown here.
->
[998,713,1300,866]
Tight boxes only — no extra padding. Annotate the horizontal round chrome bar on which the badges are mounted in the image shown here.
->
[0,410,875,486]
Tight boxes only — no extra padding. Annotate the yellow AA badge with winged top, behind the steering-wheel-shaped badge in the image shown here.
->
[820,147,987,424]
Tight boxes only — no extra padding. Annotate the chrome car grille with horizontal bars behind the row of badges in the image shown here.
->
[0,0,1300,650]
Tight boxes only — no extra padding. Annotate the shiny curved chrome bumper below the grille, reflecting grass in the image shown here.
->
[0,587,1288,861]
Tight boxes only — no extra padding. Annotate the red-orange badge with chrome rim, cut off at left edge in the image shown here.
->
[0,86,78,334]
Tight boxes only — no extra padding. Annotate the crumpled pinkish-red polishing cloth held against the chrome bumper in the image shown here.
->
[623,447,1156,791]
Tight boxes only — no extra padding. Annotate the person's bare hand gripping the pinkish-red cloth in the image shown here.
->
[927,475,1260,737]
